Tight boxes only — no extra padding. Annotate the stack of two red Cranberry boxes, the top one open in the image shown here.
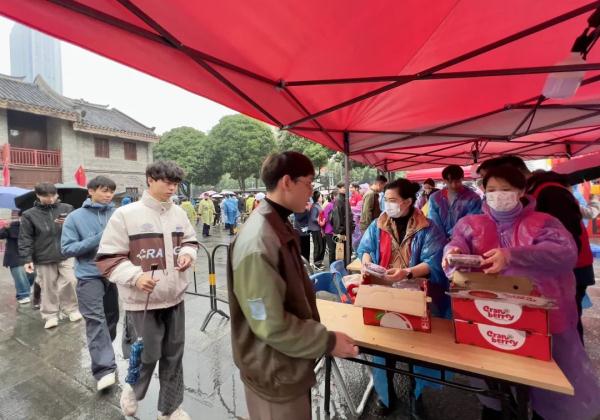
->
[450,271,553,360]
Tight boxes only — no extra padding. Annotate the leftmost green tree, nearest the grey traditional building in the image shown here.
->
[153,127,223,185]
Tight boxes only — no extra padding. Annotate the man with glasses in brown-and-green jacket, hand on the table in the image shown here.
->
[227,152,358,420]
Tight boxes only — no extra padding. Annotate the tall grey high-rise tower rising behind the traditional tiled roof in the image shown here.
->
[10,23,62,94]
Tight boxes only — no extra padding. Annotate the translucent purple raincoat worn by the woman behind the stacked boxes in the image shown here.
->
[444,197,600,420]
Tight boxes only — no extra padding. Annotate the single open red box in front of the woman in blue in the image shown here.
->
[354,279,431,332]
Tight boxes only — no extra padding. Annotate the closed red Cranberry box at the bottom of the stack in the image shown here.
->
[454,320,552,361]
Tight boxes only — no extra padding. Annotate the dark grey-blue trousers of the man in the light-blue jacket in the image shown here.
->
[77,278,119,380]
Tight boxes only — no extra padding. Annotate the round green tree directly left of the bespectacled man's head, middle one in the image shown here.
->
[208,114,275,191]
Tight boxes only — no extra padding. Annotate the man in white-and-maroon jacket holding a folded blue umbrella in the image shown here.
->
[96,161,198,420]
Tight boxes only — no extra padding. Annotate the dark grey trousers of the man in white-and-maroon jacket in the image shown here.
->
[126,302,185,415]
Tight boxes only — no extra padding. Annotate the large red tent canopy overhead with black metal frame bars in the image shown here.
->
[0,0,600,170]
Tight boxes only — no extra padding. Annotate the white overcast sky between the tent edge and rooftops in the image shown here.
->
[0,17,234,134]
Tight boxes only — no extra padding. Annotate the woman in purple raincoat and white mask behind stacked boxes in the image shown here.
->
[444,166,600,420]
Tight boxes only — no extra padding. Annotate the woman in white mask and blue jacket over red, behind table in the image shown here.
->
[357,178,450,415]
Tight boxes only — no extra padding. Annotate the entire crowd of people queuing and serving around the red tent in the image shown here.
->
[0,152,600,420]
